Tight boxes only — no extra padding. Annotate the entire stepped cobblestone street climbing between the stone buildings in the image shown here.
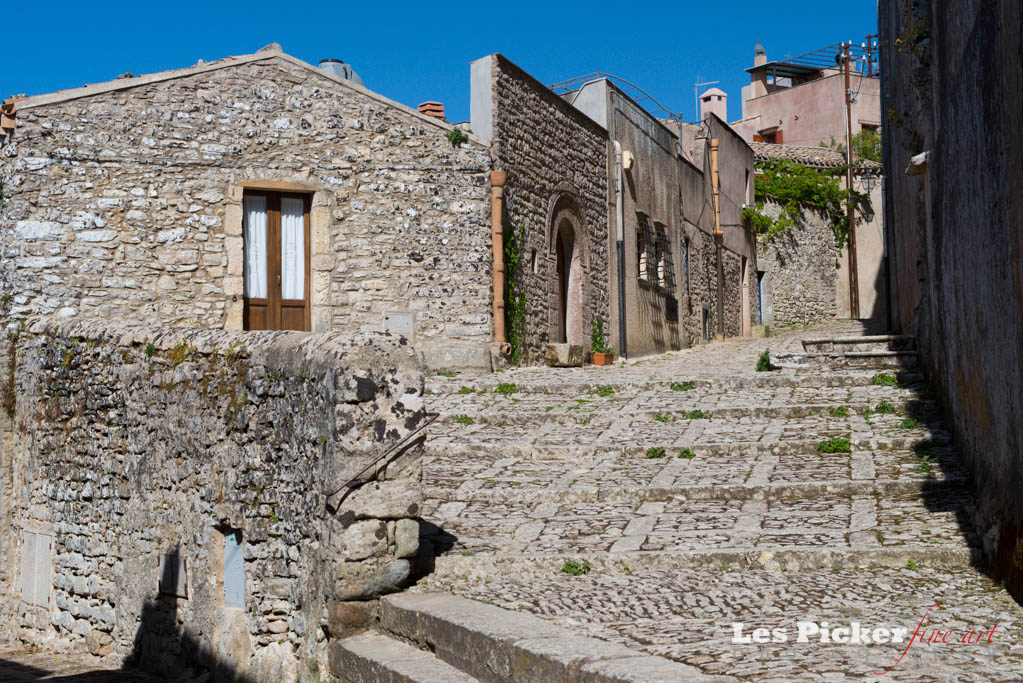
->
[417,322,1023,681]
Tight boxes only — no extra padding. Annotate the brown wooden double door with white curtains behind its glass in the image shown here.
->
[242,191,311,331]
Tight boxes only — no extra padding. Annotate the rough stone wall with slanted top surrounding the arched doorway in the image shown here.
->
[491,55,617,363]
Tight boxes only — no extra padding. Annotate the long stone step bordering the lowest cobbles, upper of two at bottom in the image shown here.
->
[381,593,737,683]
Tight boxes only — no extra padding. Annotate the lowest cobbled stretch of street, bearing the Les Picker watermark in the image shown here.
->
[422,567,1023,681]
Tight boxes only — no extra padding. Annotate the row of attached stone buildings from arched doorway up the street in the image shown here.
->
[472,59,759,360]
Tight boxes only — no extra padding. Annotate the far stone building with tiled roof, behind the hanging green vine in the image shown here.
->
[752,142,888,325]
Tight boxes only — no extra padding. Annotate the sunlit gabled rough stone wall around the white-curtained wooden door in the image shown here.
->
[0,53,492,364]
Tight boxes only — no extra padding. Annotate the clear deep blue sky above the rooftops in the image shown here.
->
[0,0,877,121]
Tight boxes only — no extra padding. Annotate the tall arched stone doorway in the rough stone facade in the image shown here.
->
[547,191,589,346]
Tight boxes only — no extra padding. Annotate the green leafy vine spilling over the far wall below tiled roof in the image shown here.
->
[743,160,866,248]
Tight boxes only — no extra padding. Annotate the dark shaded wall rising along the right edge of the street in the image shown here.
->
[879,0,1023,599]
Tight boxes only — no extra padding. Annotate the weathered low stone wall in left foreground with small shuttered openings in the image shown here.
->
[0,320,425,683]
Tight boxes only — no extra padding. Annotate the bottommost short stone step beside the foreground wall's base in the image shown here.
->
[329,633,478,683]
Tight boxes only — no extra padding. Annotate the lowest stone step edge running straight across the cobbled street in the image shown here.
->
[416,545,987,581]
